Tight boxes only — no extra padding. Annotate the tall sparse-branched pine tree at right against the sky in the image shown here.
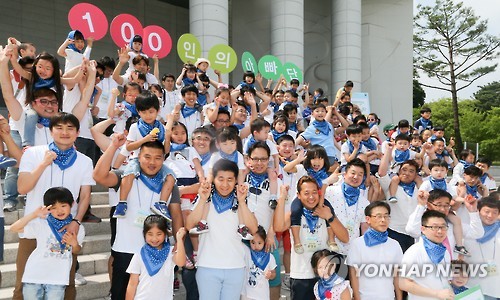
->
[413,0,500,150]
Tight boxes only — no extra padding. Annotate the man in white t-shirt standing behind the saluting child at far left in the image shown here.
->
[13,113,95,299]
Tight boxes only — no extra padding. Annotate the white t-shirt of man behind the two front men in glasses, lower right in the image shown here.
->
[378,175,418,234]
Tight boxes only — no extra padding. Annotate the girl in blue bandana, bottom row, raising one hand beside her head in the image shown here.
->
[126,215,186,300]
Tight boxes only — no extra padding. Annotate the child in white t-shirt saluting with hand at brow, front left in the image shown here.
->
[10,187,85,300]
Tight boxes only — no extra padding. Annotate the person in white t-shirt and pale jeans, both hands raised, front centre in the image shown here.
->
[186,159,257,299]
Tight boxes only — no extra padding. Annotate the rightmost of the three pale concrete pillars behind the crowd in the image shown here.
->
[331,0,363,92]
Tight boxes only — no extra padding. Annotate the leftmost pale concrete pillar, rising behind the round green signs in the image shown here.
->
[189,0,229,82]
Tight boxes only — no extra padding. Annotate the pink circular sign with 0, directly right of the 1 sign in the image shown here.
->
[110,14,146,48]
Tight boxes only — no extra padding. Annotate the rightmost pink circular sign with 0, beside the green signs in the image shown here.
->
[142,25,172,58]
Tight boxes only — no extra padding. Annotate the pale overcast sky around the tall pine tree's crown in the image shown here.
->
[413,0,500,102]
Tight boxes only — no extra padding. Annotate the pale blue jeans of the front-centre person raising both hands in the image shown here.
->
[196,267,245,300]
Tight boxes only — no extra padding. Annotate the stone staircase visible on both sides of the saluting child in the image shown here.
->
[0,192,111,300]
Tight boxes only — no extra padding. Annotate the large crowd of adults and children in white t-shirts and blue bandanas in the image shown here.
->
[0,30,500,300]
